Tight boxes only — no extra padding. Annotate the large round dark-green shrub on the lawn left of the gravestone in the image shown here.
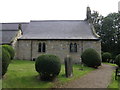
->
[35,55,61,80]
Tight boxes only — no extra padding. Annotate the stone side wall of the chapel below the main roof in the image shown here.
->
[16,40,101,63]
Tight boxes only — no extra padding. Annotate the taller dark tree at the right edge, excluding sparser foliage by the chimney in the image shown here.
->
[101,13,120,55]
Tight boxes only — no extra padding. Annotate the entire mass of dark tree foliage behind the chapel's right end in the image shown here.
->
[91,11,120,55]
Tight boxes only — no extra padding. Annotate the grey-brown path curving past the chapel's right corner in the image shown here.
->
[60,64,115,88]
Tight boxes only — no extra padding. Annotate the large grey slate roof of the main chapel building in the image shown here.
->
[20,20,99,40]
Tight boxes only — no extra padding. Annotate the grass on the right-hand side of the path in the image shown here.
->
[104,63,120,88]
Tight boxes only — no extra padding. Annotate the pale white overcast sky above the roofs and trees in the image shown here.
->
[0,0,120,23]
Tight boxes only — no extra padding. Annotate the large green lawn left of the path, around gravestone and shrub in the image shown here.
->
[2,60,94,88]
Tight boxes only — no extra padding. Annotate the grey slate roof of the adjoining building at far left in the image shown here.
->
[0,23,28,44]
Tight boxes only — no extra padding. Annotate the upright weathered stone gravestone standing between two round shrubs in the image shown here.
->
[65,56,73,77]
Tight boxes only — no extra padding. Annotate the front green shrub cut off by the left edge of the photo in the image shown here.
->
[0,48,10,76]
